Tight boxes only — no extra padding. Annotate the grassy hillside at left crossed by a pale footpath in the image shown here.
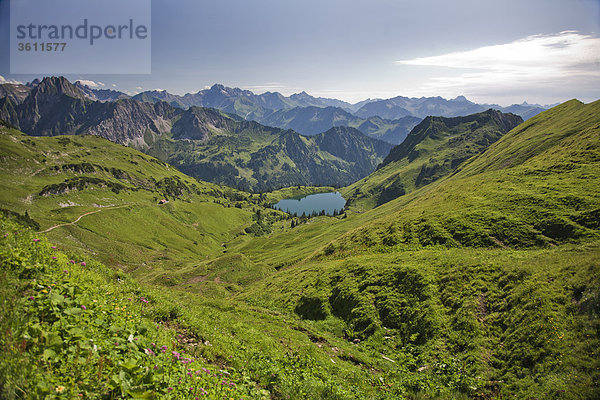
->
[0,122,284,284]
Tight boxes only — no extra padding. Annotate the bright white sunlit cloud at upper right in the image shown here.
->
[398,31,600,103]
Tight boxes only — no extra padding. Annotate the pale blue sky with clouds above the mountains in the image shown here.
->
[0,0,600,105]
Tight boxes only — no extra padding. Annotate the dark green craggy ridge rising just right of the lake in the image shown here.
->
[344,109,523,208]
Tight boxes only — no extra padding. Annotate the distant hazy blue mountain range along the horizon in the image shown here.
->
[0,79,547,145]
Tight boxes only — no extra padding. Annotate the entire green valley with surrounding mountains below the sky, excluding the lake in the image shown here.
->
[0,78,600,399]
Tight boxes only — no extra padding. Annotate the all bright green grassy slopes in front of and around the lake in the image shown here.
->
[0,97,600,400]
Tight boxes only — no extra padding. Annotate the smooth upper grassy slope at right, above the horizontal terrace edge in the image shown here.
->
[334,101,600,251]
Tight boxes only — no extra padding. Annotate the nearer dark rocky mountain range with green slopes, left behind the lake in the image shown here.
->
[0,77,392,191]
